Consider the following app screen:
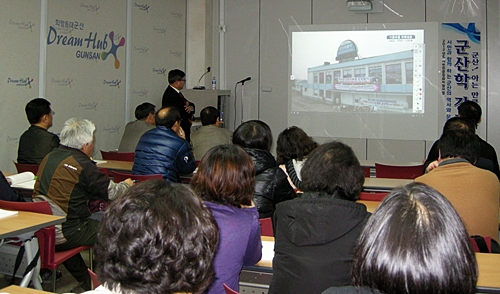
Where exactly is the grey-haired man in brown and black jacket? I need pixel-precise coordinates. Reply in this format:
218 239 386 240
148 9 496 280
33 118 133 290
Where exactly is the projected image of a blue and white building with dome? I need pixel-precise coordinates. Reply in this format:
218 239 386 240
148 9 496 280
290 29 425 114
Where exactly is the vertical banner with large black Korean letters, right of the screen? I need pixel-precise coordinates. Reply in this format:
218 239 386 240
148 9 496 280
441 23 481 120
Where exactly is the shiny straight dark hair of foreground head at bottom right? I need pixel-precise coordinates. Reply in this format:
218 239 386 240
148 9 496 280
352 183 478 293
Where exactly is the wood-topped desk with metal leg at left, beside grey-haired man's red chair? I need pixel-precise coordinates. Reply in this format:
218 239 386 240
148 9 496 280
0 211 66 290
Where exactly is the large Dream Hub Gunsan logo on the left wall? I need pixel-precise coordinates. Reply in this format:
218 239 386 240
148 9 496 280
47 26 125 69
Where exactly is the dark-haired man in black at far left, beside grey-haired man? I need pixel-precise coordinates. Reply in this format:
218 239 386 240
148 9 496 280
17 98 59 164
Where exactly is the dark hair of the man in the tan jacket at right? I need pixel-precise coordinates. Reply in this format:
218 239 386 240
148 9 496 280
438 131 481 164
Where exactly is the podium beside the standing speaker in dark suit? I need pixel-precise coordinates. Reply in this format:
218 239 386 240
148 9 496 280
181 89 231 122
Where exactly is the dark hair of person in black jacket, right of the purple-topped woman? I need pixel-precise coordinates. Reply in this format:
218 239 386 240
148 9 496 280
300 141 365 201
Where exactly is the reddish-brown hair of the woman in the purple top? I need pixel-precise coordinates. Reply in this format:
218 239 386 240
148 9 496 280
191 145 255 207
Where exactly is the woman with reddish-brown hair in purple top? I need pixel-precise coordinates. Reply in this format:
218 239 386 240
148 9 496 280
191 145 262 294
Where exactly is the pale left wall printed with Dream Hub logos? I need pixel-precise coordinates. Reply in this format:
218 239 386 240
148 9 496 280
0 0 187 173
